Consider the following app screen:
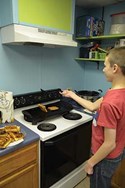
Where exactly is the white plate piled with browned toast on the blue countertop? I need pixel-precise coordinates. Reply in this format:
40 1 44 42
0 125 26 149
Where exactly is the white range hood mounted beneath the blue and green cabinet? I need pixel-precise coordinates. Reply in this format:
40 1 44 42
1 24 77 47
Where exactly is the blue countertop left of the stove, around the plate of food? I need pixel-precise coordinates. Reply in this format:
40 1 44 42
0 120 40 156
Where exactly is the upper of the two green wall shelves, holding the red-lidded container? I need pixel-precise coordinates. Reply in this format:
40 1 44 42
76 34 125 40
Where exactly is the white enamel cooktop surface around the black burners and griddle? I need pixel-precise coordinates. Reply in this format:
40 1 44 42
14 106 92 141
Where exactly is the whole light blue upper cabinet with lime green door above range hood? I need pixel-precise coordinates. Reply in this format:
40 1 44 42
0 0 75 33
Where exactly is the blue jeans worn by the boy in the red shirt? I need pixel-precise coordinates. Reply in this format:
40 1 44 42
90 153 125 188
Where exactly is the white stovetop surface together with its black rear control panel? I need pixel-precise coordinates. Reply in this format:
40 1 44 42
14 89 92 141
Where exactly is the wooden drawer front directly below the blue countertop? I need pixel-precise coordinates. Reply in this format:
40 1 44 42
0 142 38 178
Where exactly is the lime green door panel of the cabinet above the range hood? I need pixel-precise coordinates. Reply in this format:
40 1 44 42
18 0 74 33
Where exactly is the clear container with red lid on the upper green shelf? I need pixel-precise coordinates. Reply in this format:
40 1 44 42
110 12 125 34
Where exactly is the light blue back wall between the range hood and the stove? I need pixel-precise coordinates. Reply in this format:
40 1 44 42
0 42 84 94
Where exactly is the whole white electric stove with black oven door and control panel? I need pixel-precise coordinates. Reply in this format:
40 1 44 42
14 89 92 188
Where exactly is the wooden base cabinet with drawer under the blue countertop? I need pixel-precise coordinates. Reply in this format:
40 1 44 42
0 141 39 188
